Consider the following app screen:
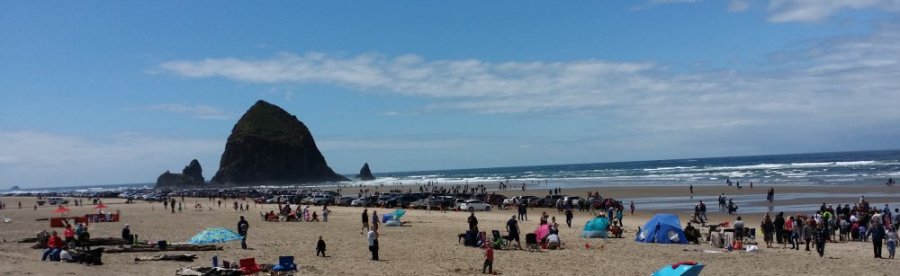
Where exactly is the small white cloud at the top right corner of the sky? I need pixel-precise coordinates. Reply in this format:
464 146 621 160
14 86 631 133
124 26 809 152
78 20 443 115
768 0 900 22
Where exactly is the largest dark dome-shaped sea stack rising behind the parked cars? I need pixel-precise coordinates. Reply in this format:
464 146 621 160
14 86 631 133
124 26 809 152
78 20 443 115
212 101 348 186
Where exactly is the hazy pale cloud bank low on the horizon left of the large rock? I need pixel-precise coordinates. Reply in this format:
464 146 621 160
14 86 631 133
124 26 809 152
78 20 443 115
0 131 225 188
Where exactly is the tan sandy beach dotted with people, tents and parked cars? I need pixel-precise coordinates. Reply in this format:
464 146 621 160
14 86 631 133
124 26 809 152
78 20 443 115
0 186 900 275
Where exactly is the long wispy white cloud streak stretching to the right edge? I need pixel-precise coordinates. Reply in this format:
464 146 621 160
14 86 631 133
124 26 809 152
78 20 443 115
160 25 900 138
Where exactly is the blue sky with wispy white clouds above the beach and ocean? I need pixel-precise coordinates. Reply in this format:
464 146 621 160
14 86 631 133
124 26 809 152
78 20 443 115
0 0 900 188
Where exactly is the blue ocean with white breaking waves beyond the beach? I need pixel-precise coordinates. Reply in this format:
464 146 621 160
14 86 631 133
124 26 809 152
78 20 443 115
8 150 900 192
